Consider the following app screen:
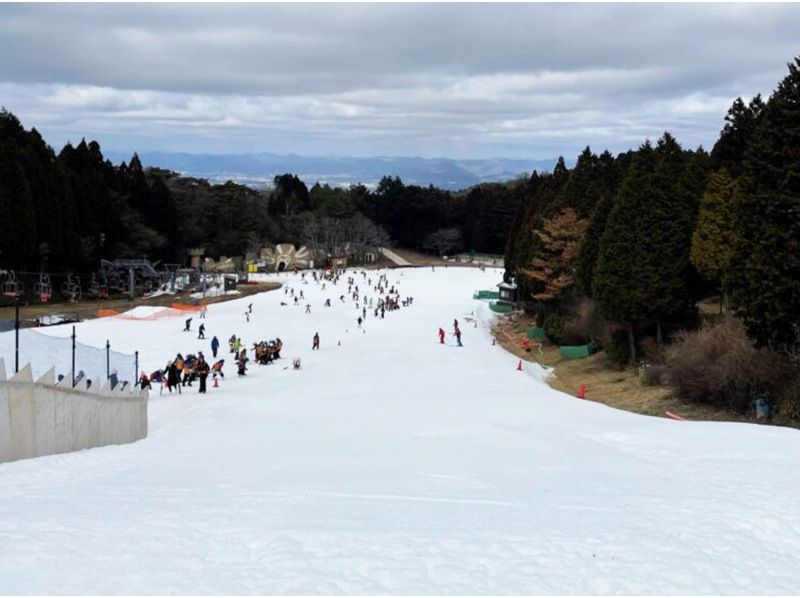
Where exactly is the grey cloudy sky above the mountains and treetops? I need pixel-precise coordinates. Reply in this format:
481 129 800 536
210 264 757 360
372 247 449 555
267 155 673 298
0 4 800 159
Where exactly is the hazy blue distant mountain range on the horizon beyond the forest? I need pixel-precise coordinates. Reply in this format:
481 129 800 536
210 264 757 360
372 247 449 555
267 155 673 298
106 152 556 189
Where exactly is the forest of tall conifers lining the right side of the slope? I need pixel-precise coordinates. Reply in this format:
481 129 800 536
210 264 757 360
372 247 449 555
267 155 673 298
505 58 800 416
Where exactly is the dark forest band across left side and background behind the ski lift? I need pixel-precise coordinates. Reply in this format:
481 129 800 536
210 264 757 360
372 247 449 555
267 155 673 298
0 110 525 271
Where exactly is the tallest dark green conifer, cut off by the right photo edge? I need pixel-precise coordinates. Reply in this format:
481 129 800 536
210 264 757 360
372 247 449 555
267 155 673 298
730 57 800 351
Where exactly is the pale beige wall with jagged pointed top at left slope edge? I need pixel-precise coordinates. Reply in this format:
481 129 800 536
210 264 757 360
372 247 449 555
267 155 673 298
0 359 148 463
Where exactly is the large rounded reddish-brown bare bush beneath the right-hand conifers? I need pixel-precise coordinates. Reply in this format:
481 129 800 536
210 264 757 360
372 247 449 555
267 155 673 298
667 317 789 413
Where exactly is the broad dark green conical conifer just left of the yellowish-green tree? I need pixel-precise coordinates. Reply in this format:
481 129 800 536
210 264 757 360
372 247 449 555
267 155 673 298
592 133 697 363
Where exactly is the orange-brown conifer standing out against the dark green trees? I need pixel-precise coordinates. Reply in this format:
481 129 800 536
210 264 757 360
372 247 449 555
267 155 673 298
520 208 588 302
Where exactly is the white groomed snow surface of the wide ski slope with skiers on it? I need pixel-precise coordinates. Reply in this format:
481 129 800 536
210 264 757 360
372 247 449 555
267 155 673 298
0 268 800 594
